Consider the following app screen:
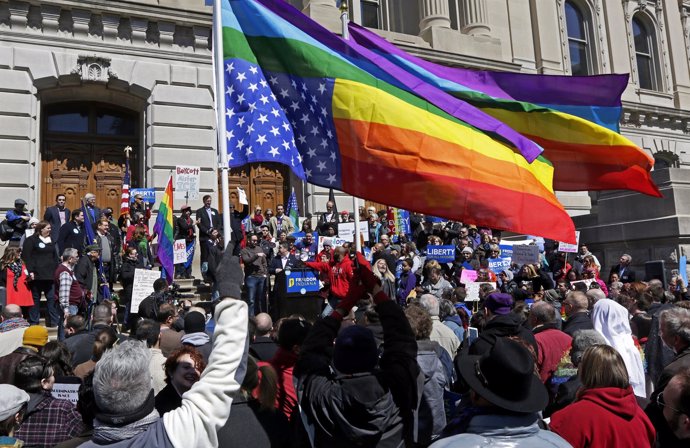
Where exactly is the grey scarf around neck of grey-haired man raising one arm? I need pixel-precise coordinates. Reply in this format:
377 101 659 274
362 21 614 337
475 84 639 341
93 389 160 445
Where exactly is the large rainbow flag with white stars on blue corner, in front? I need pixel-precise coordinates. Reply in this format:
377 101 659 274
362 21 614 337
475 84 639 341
222 0 574 242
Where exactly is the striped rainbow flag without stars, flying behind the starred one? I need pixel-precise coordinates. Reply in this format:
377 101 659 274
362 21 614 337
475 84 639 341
349 23 660 196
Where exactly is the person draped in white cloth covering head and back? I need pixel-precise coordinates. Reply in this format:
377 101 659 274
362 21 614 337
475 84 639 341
592 299 647 397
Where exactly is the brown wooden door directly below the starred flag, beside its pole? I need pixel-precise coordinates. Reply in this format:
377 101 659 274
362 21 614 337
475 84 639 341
218 163 289 213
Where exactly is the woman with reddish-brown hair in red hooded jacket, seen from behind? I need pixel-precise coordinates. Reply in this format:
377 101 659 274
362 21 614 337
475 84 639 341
550 345 656 448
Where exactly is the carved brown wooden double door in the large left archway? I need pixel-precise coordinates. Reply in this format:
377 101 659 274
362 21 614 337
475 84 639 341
42 141 137 216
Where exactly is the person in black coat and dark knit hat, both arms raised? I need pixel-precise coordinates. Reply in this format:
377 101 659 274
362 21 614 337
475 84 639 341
294 254 419 447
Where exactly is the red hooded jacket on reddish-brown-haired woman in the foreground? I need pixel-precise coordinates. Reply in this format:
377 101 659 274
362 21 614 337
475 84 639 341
550 387 656 448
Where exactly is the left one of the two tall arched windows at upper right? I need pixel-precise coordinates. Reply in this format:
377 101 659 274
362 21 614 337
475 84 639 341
565 1 596 75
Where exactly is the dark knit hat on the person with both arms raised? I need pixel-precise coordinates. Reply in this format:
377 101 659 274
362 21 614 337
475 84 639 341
333 325 379 374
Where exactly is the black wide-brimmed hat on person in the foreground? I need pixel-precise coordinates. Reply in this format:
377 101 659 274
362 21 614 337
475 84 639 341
459 338 549 413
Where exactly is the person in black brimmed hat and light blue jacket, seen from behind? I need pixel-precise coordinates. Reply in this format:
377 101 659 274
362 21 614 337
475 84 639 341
431 337 570 448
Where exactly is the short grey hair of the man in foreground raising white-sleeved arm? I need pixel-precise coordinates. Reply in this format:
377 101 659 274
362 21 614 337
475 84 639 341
93 340 152 414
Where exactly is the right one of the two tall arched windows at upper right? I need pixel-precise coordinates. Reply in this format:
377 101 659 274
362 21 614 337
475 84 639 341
632 14 661 90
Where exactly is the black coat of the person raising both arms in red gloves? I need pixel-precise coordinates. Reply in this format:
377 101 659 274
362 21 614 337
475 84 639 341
294 300 421 447
